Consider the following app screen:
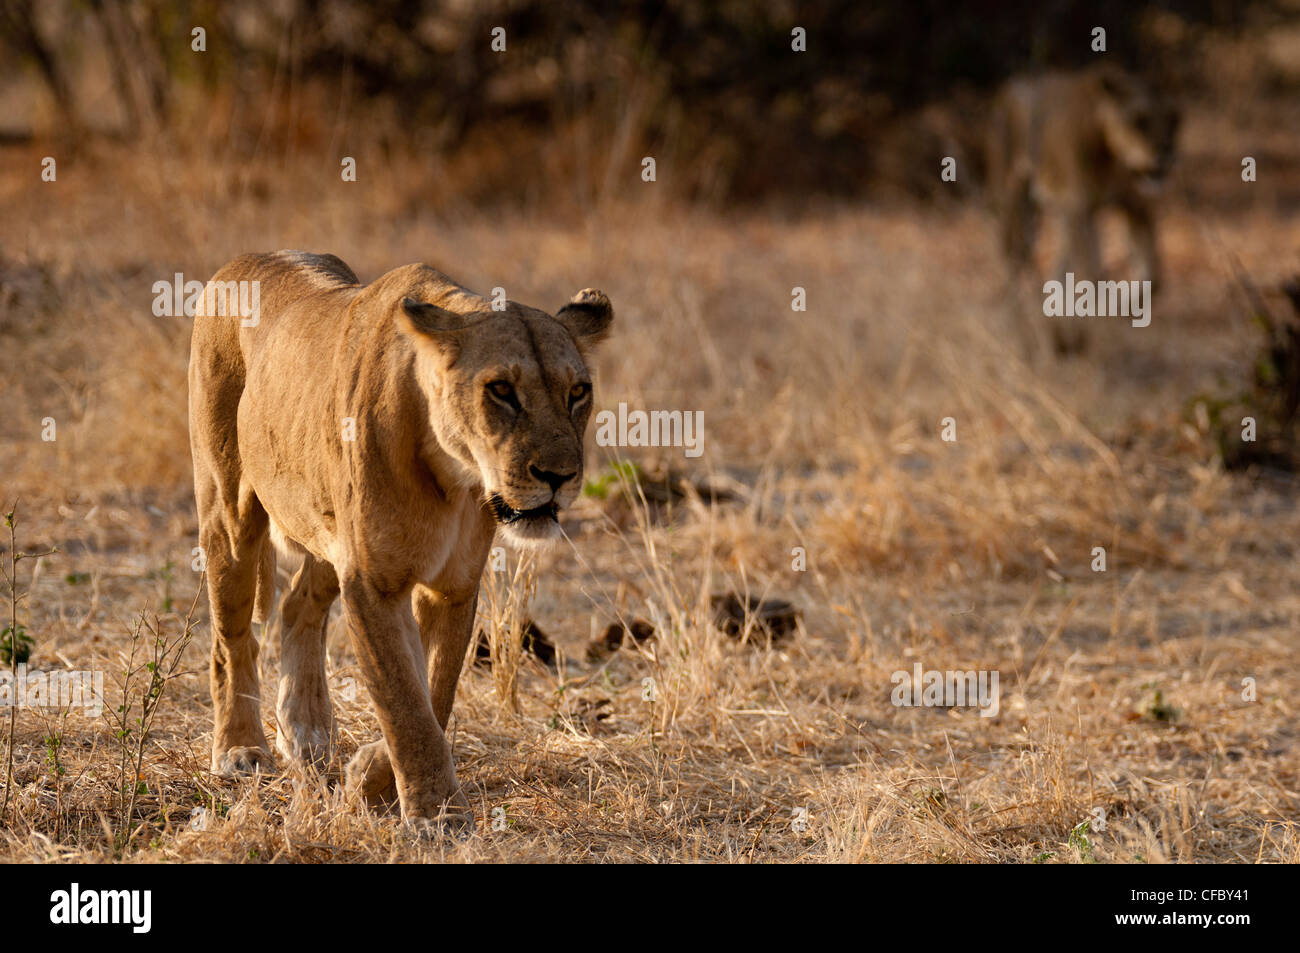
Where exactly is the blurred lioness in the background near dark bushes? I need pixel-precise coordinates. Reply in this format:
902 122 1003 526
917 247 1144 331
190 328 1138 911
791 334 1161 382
987 64 1179 351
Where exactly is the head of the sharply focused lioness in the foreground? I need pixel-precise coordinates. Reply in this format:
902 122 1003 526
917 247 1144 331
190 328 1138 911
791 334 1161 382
400 285 614 545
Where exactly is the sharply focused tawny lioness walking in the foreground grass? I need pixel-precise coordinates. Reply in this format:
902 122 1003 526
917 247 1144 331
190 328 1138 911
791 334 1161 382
190 251 614 822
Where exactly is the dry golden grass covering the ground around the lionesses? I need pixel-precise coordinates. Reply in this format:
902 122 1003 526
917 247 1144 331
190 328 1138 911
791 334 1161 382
0 91 1300 862
